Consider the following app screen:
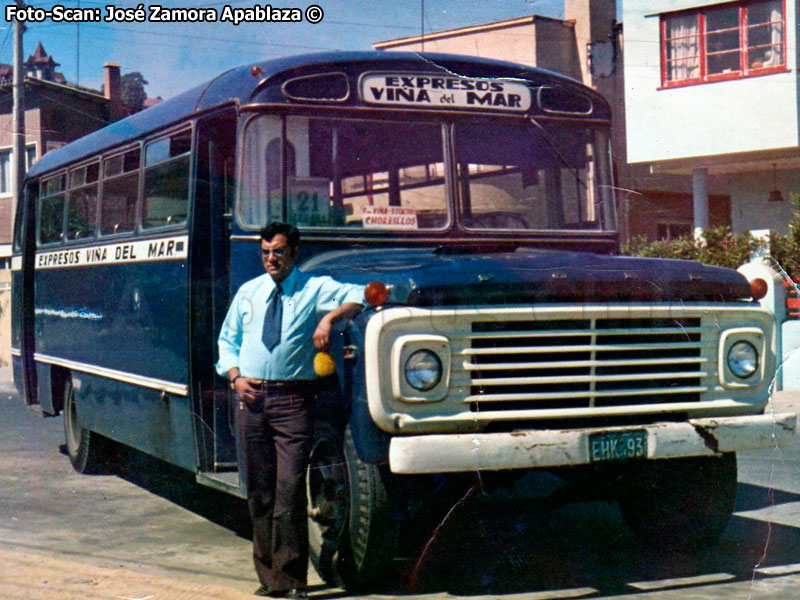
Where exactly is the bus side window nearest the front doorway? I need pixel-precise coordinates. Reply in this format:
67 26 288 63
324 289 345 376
142 129 192 229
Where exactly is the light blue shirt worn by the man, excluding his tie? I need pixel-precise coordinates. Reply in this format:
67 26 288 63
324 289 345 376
217 269 365 380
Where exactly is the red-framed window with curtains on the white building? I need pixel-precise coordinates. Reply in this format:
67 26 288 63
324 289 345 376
661 0 786 87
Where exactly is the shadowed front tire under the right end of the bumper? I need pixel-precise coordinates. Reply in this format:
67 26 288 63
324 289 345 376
618 453 736 552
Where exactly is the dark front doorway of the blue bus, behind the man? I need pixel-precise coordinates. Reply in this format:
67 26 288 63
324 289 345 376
189 110 240 492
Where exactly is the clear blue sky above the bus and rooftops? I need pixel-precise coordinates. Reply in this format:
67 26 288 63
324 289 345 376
0 0 564 99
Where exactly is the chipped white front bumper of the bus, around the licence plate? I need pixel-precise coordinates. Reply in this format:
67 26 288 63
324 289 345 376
389 413 797 474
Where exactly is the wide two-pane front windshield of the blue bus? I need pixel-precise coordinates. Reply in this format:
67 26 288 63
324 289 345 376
237 115 614 232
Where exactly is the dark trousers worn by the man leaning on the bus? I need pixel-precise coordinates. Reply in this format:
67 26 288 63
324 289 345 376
237 392 312 590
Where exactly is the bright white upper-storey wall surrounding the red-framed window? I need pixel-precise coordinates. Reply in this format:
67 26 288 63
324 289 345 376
622 0 798 162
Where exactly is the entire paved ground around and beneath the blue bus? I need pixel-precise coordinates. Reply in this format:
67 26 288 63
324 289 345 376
0 384 800 600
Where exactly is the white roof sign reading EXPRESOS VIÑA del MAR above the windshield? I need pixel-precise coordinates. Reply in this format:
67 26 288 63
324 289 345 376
361 73 531 112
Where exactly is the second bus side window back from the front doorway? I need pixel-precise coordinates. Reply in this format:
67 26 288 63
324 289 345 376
100 148 140 235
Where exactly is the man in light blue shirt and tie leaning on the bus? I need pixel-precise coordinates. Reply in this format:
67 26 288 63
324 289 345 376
217 223 364 598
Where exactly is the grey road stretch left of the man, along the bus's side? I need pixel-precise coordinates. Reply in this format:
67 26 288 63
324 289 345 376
0 386 268 600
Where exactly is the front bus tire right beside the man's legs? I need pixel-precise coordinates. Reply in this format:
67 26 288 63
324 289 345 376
308 421 398 590
